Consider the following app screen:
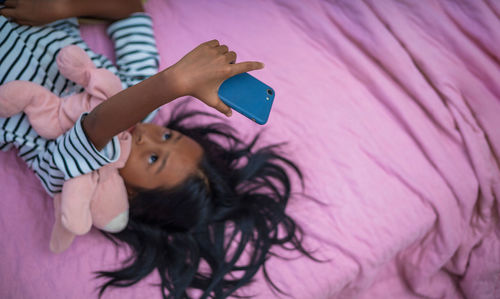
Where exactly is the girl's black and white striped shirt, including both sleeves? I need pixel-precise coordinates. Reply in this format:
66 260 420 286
0 13 159 195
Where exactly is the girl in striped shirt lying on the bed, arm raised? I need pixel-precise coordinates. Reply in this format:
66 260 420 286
0 0 313 298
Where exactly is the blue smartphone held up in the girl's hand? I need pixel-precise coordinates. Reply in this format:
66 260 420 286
218 73 275 125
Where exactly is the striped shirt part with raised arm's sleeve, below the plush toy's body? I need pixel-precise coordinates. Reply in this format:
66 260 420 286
0 113 120 196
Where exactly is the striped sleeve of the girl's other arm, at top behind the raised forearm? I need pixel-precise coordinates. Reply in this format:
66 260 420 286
107 13 159 86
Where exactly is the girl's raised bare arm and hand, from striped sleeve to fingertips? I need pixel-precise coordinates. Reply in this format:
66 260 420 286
82 40 264 150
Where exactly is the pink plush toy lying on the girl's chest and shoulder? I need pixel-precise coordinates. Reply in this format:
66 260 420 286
0 46 131 253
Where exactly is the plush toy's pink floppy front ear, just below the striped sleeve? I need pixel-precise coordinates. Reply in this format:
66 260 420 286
61 171 99 235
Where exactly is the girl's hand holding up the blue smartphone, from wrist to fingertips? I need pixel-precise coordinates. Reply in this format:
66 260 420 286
168 40 264 117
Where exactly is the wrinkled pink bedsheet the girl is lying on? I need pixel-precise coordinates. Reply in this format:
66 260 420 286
0 0 500 299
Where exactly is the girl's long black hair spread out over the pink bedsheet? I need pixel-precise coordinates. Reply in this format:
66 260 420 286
98 104 316 298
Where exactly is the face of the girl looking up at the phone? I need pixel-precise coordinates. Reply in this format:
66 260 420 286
120 123 203 191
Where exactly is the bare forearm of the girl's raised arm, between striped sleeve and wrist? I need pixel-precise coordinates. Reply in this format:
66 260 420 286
82 69 180 150
